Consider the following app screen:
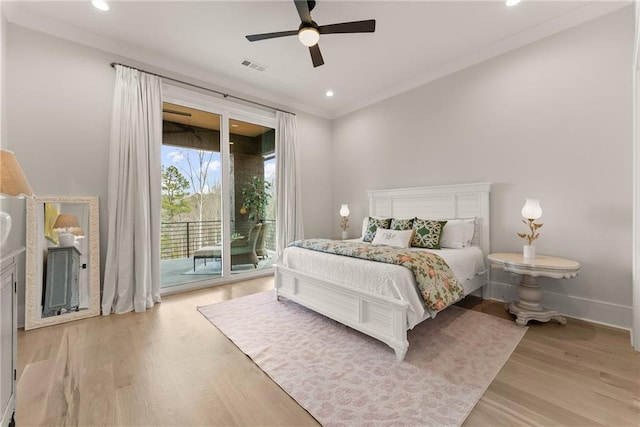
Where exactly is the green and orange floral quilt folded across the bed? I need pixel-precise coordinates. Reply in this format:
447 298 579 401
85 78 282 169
289 239 464 316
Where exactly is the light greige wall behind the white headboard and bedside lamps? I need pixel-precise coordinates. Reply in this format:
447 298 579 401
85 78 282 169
333 7 634 328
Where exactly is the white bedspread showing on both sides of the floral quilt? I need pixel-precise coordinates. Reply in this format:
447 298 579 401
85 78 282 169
280 246 485 328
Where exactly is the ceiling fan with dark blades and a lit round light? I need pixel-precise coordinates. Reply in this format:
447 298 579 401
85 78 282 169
246 0 376 67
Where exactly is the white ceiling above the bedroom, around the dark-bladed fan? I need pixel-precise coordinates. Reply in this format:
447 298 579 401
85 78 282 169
2 0 631 118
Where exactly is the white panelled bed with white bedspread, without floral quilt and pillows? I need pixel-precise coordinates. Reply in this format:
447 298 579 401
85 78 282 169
275 183 491 361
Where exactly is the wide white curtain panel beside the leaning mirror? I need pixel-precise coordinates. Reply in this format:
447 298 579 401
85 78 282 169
102 65 162 315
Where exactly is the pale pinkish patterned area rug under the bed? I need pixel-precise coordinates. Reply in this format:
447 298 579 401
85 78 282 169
198 291 526 426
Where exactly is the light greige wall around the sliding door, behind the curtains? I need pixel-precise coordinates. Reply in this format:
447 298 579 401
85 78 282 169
3 24 332 320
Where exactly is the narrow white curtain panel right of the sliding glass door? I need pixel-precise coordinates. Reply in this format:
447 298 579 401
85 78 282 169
276 111 304 258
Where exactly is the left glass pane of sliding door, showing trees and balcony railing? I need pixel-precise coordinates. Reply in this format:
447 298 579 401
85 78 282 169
160 103 222 287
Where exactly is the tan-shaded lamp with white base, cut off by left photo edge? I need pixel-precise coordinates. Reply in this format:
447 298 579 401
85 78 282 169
0 150 33 246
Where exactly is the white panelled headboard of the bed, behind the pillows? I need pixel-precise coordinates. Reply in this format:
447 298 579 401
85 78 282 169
367 182 491 255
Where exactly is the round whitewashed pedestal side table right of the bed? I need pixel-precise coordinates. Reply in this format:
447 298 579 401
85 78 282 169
488 253 580 326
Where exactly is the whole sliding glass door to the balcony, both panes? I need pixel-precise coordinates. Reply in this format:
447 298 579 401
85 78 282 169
161 97 277 289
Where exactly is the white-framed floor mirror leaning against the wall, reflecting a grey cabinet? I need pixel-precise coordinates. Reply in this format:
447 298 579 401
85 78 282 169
25 196 100 330
